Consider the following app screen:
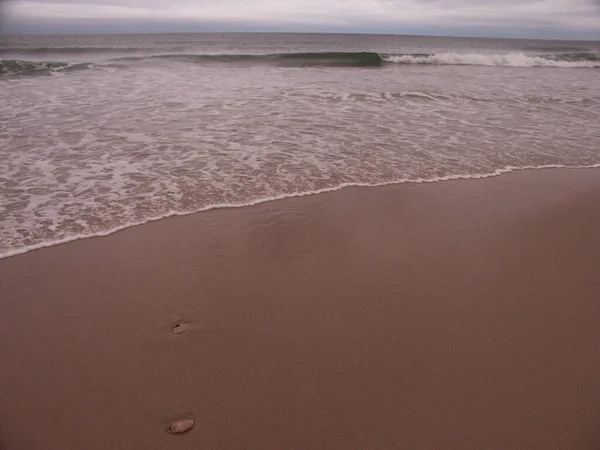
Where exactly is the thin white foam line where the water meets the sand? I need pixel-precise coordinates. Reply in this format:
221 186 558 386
0 163 600 261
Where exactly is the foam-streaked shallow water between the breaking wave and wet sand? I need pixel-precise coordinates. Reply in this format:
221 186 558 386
0 61 600 257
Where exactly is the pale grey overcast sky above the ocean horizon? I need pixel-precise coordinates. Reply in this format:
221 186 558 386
0 0 600 39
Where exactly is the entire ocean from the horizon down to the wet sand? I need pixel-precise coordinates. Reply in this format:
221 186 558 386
0 34 600 257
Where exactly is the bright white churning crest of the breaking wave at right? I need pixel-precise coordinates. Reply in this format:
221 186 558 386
384 52 600 68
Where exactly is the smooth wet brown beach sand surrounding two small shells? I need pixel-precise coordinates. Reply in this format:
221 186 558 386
0 170 600 450
